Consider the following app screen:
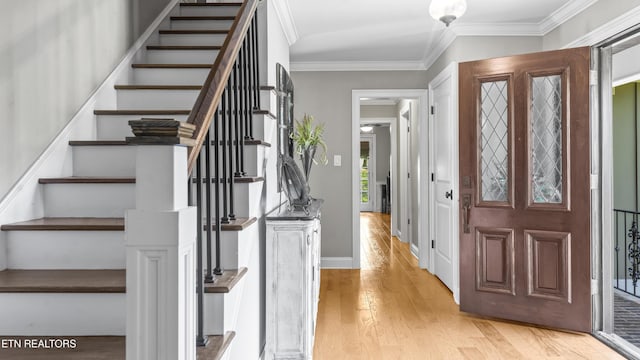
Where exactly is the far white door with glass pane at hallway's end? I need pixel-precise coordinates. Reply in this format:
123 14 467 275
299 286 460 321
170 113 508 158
359 134 376 211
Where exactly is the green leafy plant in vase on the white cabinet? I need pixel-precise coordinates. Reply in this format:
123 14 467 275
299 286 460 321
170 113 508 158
291 114 328 183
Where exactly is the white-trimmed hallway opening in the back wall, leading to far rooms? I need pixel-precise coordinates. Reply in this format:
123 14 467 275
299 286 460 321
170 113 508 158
352 90 427 268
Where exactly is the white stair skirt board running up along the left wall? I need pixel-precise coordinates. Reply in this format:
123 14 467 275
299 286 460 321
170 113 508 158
0 0 179 270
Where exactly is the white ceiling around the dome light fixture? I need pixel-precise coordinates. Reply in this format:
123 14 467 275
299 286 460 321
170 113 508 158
274 0 597 70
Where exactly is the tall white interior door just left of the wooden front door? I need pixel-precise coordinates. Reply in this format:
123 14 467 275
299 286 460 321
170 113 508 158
429 63 458 291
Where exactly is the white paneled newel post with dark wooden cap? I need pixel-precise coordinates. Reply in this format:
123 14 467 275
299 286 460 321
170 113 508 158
125 119 196 360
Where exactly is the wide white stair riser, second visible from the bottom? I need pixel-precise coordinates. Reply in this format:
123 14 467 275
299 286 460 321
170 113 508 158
7 231 125 270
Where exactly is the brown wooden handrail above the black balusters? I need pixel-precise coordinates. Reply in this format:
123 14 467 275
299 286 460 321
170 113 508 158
187 0 258 174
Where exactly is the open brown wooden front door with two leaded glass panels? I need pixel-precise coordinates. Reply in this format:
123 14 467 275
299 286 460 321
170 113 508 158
459 48 591 332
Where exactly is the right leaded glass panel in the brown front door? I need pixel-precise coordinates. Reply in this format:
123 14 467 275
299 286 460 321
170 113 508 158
530 75 563 204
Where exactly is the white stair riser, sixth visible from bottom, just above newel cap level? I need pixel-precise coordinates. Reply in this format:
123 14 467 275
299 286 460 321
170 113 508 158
118 90 200 110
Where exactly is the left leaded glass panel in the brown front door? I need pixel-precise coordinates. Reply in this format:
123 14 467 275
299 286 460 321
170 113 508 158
480 80 509 202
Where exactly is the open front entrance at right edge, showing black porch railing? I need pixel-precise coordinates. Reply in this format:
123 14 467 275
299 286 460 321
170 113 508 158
605 36 640 351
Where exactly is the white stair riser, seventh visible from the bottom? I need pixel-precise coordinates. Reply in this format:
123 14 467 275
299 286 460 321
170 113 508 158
133 68 211 85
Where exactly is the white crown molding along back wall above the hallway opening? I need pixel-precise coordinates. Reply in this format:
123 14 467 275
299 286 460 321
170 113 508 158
289 60 426 71
